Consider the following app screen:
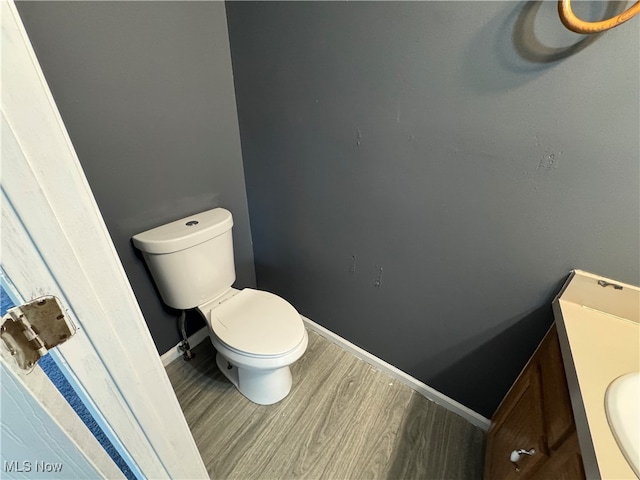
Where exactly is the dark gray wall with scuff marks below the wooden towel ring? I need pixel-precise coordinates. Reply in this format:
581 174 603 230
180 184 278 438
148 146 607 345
227 1 640 416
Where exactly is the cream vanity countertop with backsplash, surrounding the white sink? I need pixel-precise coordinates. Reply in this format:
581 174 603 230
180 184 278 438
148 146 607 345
553 270 640 480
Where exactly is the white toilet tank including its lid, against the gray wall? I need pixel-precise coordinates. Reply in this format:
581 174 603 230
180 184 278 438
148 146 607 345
133 208 236 310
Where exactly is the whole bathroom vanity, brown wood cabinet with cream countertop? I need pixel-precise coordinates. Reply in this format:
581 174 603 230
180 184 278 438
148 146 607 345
484 271 640 480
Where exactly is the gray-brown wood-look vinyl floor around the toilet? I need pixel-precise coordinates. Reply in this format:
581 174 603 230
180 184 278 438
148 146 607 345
167 331 485 480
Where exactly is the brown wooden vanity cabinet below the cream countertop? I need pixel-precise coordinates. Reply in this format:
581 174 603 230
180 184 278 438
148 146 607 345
484 325 585 480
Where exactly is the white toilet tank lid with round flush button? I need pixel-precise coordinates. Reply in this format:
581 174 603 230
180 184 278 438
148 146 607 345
133 208 233 254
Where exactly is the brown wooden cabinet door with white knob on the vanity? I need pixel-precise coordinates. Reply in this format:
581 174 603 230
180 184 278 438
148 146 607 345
485 362 548 480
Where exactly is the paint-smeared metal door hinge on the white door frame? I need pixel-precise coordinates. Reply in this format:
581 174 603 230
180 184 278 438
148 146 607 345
0 296 76 370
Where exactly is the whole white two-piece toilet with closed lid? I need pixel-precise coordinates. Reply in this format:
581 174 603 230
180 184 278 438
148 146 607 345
133 208 308 405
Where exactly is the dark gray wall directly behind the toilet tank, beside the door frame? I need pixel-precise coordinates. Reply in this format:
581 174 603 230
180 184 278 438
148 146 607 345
18 1 255 353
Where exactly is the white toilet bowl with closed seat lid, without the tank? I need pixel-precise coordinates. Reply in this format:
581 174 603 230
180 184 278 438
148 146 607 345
198 288 308 405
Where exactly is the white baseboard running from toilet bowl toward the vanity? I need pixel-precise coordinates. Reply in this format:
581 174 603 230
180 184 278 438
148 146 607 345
302 316 491 431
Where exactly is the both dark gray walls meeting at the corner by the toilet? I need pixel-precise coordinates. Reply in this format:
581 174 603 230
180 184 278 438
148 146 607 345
18 1 640 416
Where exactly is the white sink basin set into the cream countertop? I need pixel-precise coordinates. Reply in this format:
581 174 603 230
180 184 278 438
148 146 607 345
605 372 640 478
